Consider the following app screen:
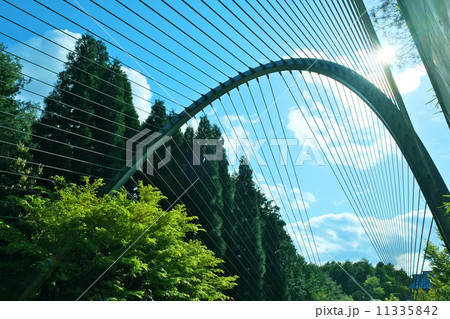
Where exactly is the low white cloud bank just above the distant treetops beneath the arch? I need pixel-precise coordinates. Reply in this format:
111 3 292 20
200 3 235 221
286 210 431 270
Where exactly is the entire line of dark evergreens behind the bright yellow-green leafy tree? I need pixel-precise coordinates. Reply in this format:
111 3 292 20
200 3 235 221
0 35 414 300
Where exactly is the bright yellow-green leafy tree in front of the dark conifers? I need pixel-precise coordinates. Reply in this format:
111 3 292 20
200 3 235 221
0 179 236 300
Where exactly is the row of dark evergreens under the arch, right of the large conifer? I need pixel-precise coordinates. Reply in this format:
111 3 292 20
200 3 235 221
139 100 344 300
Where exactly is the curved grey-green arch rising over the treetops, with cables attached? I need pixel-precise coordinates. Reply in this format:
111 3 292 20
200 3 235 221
104 58 450 251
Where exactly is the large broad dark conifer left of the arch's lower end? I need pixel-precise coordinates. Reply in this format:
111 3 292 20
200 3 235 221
34 34 139 181
